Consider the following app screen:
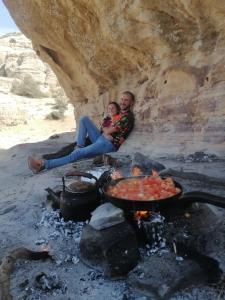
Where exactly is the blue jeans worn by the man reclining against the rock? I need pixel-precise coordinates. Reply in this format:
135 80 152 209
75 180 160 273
45 117 117 169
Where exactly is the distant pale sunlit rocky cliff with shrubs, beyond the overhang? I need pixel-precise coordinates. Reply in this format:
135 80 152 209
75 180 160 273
0 33 65 98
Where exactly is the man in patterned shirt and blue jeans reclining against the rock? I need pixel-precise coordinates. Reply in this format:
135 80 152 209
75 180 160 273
28 91 135 173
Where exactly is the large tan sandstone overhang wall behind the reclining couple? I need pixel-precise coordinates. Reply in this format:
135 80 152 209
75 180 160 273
3 0 225 156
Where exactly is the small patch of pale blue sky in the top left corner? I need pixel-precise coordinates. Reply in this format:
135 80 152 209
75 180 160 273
0 0 20 35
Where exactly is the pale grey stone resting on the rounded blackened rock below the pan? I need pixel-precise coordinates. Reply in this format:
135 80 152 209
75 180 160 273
89 203 125 230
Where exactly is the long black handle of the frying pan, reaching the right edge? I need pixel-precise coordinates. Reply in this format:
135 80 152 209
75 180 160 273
178 191 225 208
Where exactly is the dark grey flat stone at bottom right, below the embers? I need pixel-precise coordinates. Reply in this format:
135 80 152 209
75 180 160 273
128 252 204 299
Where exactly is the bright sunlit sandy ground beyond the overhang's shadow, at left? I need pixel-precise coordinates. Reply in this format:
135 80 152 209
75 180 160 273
0 92 76 149
